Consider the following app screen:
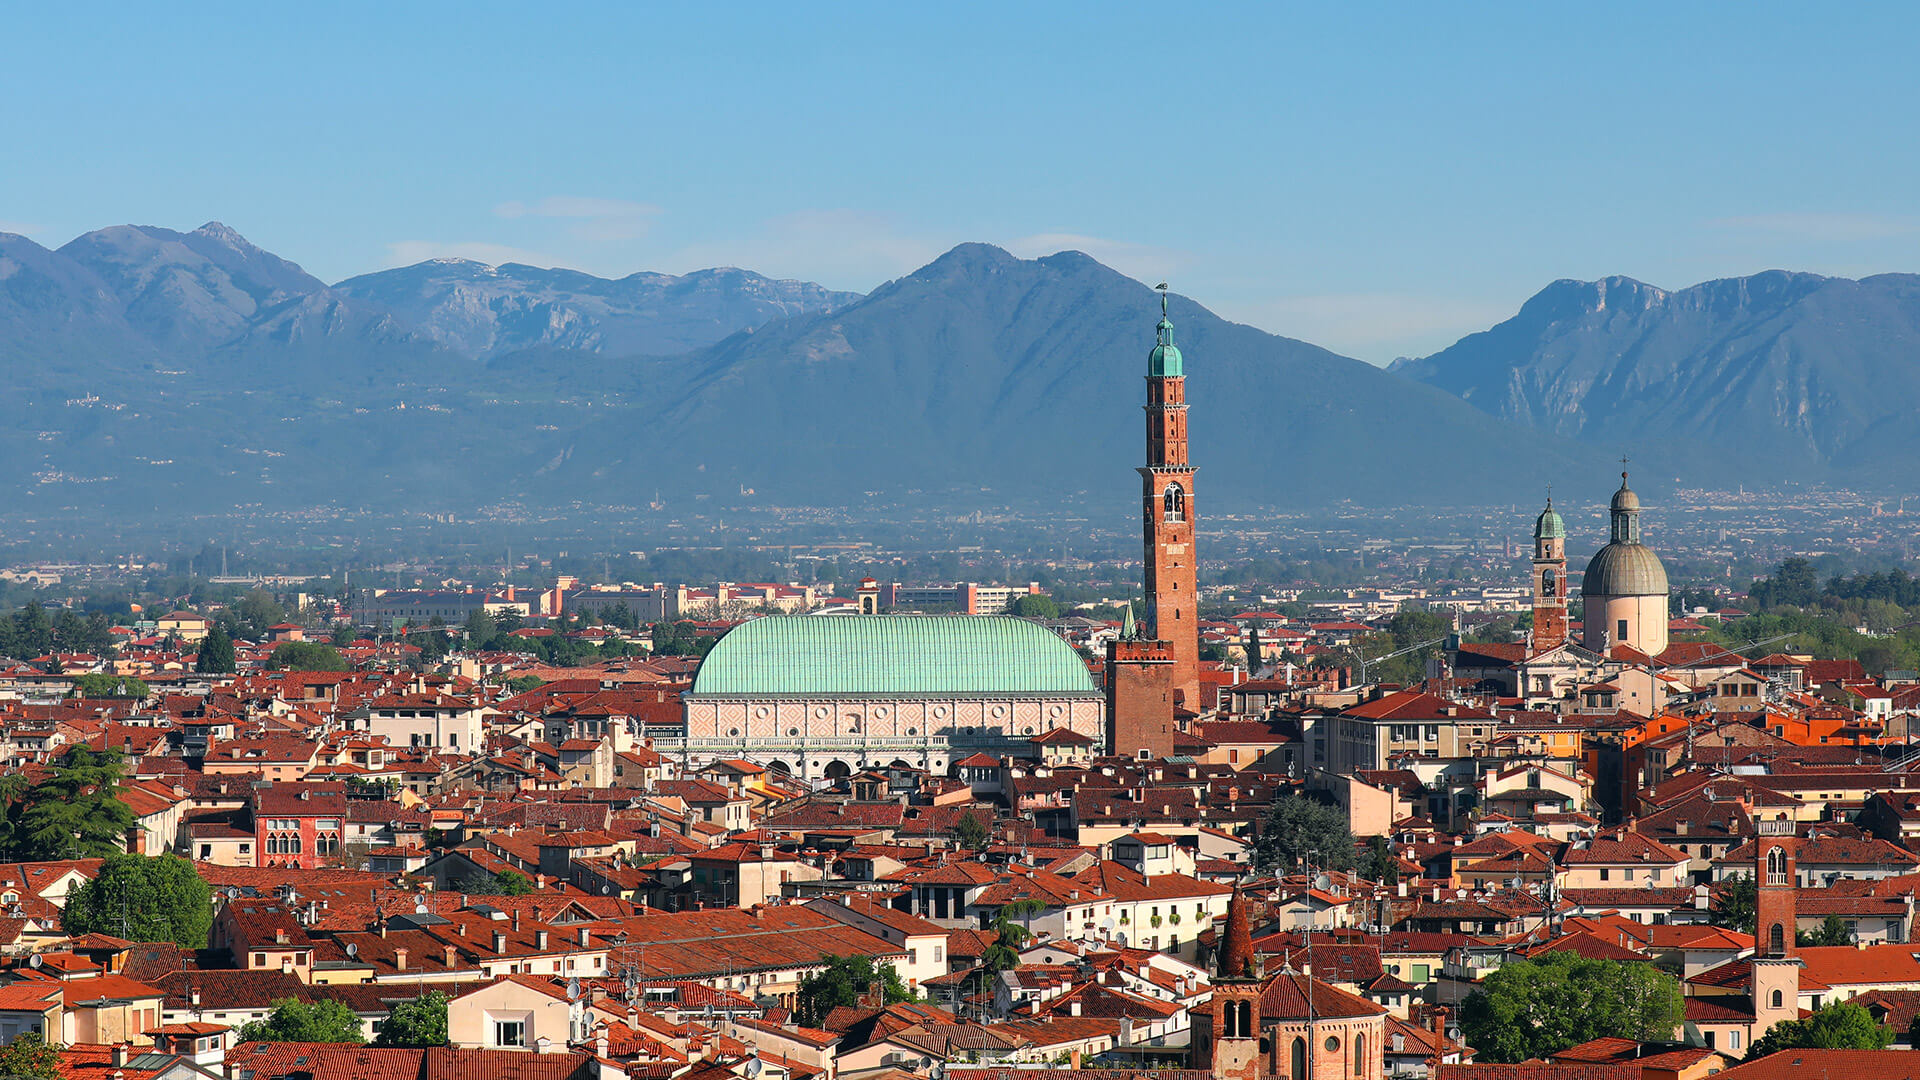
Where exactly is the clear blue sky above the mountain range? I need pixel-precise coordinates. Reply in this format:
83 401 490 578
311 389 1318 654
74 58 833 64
0 2 1920 363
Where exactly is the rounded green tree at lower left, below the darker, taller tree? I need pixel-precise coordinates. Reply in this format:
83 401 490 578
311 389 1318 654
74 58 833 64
60 855 213 949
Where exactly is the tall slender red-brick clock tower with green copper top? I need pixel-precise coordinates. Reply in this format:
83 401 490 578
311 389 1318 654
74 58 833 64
1140 284 1200 709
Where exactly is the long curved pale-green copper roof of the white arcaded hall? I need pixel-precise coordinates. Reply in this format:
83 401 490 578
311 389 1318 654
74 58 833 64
693 615 1098 698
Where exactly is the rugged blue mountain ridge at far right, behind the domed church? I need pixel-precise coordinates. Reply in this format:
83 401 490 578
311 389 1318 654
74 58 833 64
1392 271 1920 484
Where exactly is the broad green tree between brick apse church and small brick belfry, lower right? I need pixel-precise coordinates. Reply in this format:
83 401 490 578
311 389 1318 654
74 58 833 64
1459 953 1686 1063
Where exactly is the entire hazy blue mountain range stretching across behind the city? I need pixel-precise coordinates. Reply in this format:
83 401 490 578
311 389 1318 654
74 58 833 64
0 223 1896 513
